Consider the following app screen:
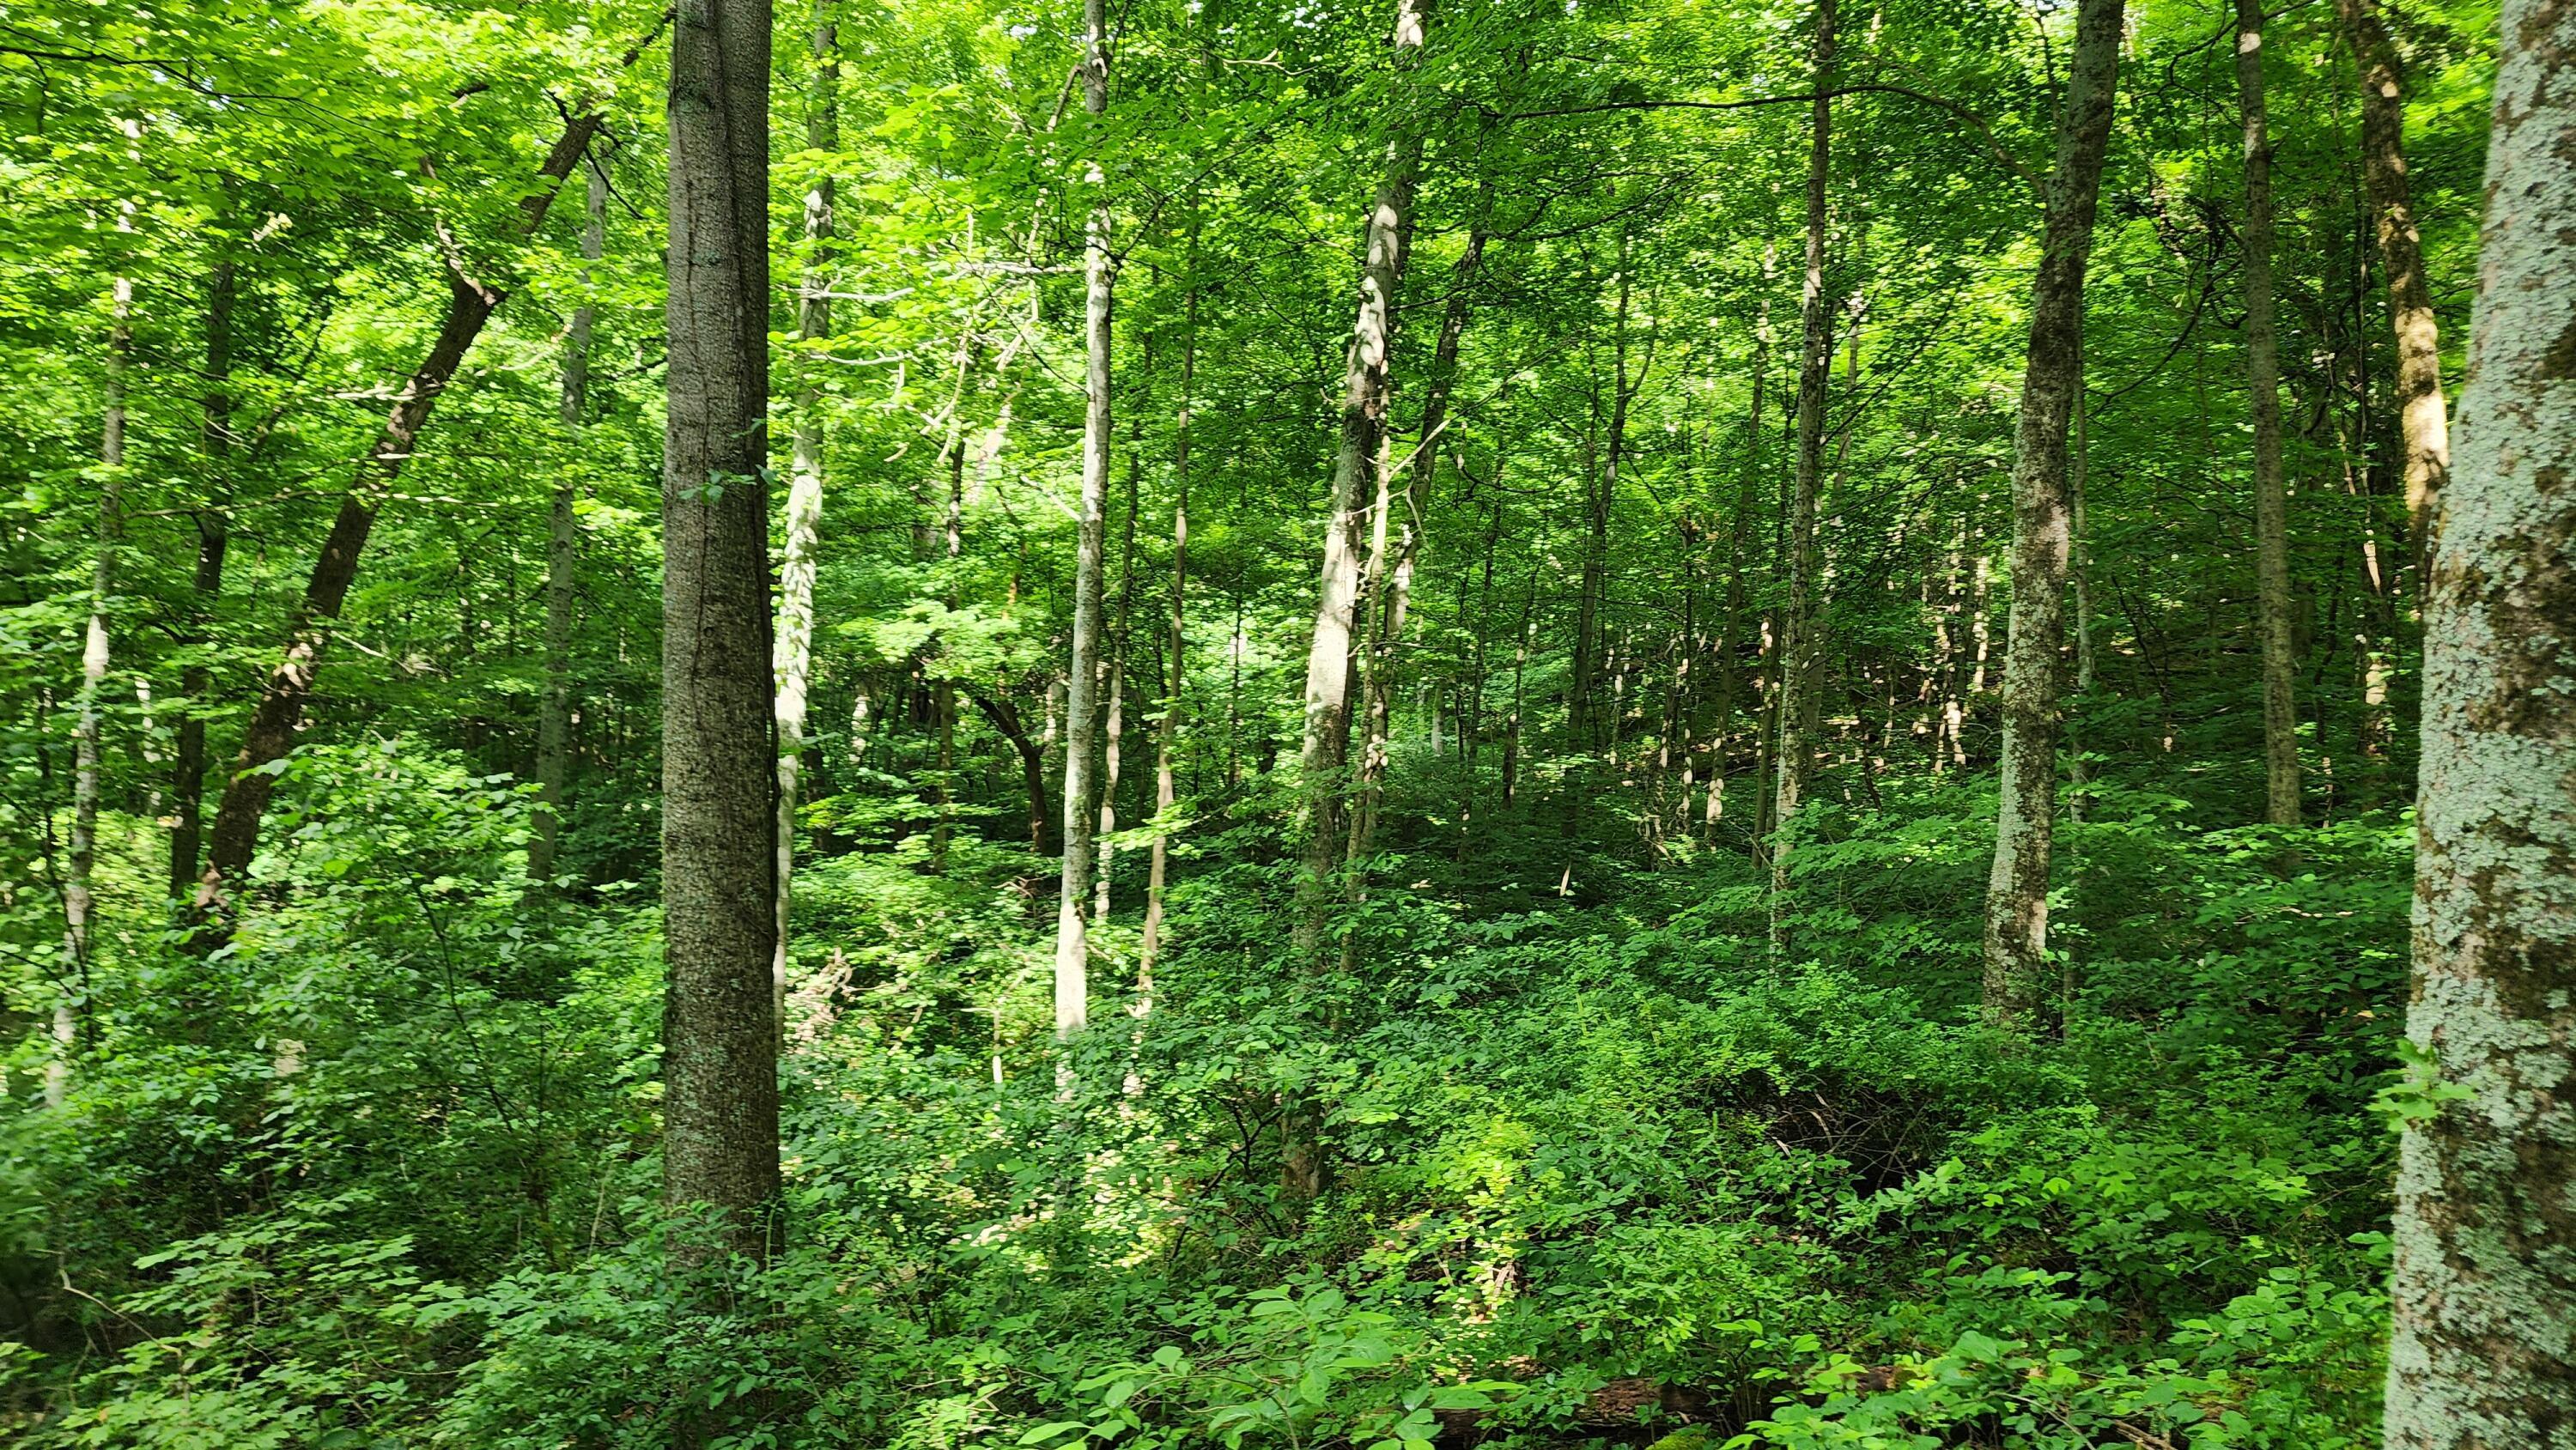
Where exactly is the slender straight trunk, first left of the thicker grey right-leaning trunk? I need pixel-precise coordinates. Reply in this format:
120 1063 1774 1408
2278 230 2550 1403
1770 0 1834 950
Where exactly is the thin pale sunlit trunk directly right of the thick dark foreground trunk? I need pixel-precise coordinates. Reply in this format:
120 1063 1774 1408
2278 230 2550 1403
770 0 840 1030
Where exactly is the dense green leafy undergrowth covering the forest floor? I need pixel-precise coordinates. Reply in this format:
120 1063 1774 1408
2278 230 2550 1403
0 755 2406 1450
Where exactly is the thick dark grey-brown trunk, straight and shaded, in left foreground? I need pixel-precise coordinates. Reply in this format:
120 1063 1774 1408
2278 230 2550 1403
662 0 778 1257
